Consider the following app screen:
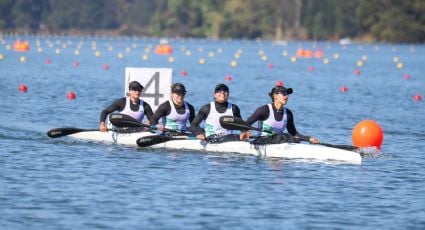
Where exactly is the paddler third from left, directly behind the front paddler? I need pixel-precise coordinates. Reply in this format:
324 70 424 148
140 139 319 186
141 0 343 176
190 84 241 141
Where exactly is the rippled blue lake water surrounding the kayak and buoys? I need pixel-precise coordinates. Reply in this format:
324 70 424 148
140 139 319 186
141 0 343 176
0 36 425 229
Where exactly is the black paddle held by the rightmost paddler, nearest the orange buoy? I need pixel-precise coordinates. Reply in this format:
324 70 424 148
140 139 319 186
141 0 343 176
220 116 357 150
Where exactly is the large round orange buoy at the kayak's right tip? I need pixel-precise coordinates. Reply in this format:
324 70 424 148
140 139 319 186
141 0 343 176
352 120 384 149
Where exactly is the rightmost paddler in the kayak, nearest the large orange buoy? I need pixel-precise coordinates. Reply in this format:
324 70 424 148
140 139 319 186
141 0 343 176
240 86 320 144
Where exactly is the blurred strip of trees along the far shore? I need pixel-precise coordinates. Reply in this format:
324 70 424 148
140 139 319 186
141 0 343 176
0 0 425 43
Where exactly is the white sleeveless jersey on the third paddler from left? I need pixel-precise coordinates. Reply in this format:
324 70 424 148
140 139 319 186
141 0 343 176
205 102 233 137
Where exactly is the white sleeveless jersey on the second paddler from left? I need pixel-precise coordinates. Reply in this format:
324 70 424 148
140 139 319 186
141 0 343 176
162 100 190 131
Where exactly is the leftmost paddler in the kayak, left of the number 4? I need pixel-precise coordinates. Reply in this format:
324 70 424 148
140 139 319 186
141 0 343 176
99 81 153 132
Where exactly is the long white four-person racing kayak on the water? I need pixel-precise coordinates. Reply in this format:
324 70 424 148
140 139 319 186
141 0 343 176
68 131 362 164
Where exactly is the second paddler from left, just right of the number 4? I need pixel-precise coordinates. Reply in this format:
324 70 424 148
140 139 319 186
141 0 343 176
151 83 195 132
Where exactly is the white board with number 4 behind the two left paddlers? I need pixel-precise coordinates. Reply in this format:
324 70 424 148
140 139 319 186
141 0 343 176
124 67 173 111
